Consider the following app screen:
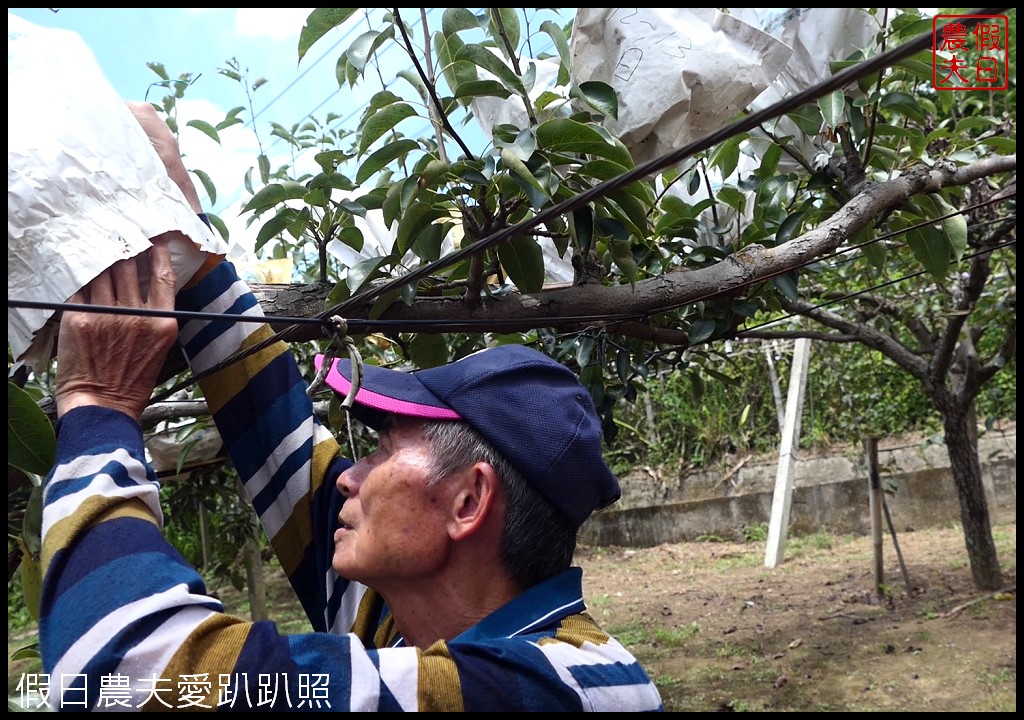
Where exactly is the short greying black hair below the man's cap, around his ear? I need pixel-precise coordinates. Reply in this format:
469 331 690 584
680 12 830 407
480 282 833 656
423 420 577 590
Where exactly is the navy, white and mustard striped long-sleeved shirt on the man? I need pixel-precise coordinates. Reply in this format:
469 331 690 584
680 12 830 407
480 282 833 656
39 262 664 712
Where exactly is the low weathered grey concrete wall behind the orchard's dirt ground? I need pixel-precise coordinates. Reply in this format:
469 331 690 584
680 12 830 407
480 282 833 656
581 425 1017 547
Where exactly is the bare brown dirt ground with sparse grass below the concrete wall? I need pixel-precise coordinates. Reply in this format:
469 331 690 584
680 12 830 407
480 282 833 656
578 523 1017 712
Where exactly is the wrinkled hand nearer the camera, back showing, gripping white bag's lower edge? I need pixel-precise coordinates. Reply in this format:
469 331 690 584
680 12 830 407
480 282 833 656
56 236 178 420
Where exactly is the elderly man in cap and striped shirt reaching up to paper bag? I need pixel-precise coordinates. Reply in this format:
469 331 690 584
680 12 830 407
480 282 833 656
40 104 663 712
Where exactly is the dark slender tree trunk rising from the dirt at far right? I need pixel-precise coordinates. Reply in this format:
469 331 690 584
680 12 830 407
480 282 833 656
937 400 1002 590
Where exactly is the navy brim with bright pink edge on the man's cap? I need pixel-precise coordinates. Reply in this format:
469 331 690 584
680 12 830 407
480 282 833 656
313 354 462 428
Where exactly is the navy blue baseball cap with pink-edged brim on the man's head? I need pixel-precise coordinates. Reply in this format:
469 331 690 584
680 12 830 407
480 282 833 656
315 345 622 527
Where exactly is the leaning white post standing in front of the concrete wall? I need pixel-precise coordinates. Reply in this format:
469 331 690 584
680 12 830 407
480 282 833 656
765 338 811 567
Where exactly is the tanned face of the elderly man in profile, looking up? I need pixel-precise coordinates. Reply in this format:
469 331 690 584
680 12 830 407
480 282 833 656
332 417 451 593
